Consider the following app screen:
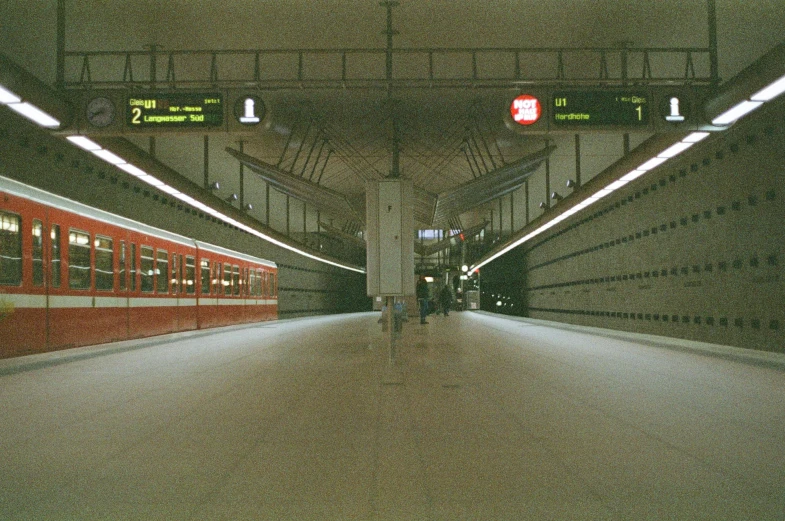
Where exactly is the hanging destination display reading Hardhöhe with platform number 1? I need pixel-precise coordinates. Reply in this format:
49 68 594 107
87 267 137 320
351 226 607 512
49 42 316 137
551 90 651 127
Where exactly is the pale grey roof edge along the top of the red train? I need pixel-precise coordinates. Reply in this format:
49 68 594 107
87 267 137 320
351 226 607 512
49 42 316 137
0 176 276 268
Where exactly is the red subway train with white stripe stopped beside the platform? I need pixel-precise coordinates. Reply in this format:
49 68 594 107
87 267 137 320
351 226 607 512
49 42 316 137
0 176 278 358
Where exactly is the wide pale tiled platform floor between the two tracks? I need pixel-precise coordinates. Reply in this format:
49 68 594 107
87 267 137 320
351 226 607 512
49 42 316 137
0 312 785 521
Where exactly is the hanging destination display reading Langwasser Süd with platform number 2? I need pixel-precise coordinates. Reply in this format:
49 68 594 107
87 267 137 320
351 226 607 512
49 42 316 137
126 92 224 129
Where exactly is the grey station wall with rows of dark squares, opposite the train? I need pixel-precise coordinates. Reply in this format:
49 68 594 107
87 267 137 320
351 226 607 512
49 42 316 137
520 103 785 352
